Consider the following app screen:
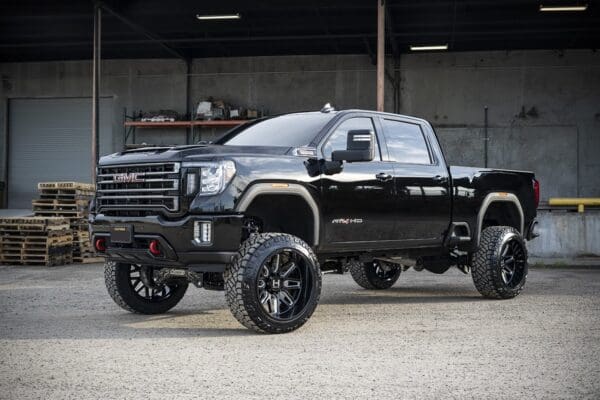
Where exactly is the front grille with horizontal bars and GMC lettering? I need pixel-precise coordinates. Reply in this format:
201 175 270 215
96 163 181 216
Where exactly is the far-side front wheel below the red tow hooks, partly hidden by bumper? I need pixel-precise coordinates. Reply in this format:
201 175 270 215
104 261 188 314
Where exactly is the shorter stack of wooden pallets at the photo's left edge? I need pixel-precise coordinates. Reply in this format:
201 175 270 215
0 217 73 266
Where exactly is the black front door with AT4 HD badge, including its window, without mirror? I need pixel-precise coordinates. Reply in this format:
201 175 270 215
321 115 396 251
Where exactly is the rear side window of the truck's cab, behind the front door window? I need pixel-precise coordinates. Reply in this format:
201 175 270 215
383 119 431 164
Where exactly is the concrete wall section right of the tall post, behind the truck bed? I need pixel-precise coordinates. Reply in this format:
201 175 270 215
402 51 600 199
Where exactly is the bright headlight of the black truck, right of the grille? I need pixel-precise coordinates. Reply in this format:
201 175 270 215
183 160 235 196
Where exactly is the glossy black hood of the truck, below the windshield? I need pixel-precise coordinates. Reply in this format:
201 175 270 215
98 144 291 166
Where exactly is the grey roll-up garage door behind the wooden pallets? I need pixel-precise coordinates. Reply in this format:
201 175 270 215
7 98 114 209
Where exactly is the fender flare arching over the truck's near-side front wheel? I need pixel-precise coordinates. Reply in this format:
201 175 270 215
235 182 321 246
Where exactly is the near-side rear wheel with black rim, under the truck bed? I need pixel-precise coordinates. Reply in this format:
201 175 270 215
471 226 528 299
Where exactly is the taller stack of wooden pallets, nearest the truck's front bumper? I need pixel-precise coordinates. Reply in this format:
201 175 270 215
32 182 102 263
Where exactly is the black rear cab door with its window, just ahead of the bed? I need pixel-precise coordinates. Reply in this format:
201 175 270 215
378 116 450 246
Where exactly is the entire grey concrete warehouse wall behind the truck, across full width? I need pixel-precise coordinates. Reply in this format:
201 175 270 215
0 50 600 199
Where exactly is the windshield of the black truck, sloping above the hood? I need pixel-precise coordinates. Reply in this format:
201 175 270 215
216 113 333 147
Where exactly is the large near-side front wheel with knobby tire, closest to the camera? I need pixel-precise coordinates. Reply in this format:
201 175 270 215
224 233 321 333
